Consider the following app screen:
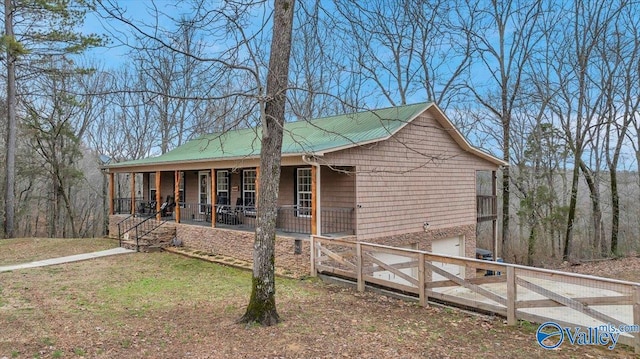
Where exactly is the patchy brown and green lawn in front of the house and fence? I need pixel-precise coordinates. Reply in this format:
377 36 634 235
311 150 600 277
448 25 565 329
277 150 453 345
0 239 634 358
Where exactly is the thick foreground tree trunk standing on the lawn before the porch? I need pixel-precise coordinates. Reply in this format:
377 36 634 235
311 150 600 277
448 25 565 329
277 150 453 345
240 0 295 326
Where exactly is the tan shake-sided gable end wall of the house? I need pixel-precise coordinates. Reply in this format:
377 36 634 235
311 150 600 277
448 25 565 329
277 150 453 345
323 111 495 240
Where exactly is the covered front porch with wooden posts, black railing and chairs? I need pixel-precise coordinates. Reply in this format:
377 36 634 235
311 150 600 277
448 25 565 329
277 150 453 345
110 166 356 237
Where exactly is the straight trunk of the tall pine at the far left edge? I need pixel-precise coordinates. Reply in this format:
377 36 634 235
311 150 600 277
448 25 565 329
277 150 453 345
4 0 17 238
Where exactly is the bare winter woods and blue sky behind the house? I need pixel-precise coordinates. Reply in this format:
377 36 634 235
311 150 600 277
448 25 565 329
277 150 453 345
0 0 640 265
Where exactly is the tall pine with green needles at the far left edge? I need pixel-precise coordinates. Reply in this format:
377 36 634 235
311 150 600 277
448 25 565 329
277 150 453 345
3 0 103 237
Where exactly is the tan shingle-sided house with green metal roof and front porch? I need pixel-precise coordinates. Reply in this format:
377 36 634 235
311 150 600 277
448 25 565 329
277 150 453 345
107 103 507 272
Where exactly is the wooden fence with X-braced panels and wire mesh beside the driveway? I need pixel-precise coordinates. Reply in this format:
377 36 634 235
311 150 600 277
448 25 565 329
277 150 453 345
311 236 640 353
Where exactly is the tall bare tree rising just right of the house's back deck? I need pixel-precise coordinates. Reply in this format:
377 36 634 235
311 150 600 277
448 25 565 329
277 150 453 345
464 0 544 255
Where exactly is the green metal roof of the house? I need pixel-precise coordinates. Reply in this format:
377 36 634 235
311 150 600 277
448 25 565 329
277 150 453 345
108 102 431 167
